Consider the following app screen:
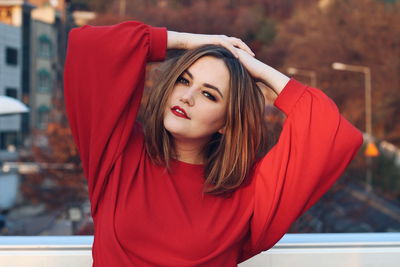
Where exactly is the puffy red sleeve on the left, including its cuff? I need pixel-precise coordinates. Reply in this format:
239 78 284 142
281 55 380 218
64 21 167 216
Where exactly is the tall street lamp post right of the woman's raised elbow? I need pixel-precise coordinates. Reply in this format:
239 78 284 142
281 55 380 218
332 62 378 191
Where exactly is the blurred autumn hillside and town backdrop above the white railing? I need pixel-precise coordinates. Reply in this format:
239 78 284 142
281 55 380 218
0 0 400 238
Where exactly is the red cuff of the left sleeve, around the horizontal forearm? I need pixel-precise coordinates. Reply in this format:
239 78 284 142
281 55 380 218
149 27 167 61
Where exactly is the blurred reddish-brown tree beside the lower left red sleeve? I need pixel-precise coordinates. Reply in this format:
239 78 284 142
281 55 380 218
21 99 88 210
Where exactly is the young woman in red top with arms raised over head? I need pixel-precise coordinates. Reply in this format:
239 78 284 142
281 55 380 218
65 21 362 266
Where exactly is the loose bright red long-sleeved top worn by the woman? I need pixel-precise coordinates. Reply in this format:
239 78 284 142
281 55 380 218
65 21 363 267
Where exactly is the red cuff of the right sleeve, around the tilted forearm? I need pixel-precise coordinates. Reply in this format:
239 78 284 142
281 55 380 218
274 78 307 115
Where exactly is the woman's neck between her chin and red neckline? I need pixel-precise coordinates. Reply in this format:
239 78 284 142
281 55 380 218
174 139 206 164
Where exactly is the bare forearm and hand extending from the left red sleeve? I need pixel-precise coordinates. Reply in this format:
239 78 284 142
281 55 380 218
167 31 255 58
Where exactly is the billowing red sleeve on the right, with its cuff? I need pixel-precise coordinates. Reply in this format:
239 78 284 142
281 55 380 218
240 79 363 261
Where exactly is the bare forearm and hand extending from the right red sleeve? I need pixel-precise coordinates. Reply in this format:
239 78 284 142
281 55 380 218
235 48 290 95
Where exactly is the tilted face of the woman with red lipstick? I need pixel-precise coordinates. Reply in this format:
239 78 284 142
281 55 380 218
164 56 230 141
